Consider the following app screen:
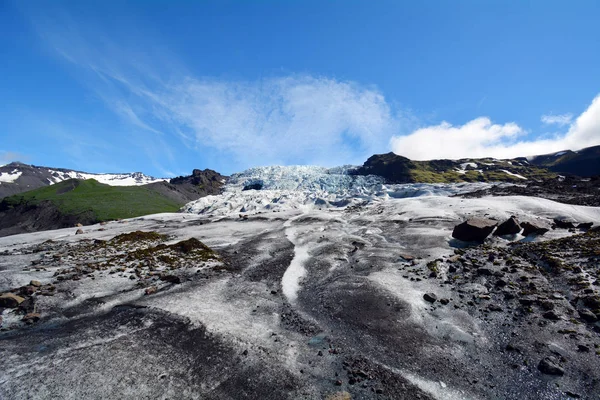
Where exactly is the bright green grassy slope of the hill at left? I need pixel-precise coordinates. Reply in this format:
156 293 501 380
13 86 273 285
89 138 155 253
0 179 182 222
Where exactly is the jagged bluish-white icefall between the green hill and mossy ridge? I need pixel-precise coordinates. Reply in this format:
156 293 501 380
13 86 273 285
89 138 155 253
182 165 489 216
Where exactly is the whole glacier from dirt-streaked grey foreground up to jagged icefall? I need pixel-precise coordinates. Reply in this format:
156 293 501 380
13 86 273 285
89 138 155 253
0 180 600 399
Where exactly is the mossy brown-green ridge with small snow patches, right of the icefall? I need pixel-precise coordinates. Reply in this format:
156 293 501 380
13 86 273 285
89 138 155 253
352 153 556 183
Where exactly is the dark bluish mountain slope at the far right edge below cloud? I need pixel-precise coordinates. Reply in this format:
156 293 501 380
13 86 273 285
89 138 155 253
529 146 600 177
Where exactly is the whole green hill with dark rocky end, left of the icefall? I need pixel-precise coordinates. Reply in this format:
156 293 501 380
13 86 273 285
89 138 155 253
0 170 227 236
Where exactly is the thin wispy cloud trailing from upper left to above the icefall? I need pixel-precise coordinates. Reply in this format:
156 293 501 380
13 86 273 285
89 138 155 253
25 9 402 168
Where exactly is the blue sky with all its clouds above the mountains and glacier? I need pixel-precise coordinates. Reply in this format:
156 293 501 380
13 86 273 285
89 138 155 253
0 0 600 176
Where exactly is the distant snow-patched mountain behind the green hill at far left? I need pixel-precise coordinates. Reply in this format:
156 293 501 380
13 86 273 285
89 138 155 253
0 162 168 198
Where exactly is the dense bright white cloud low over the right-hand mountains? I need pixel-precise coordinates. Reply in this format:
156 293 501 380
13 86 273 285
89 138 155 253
390 96 600 160
